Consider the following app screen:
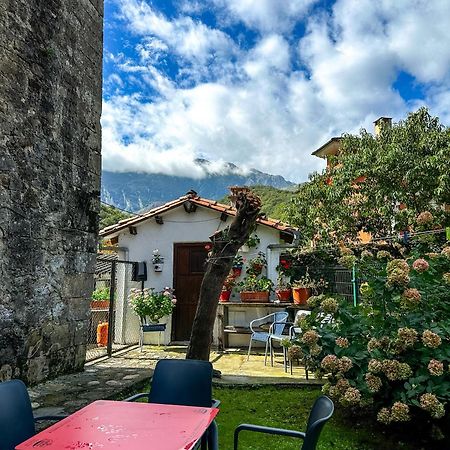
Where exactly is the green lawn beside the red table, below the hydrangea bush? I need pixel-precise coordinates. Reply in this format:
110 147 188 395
214 387 420 450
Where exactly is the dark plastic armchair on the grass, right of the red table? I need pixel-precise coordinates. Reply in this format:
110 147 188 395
234 395 334 450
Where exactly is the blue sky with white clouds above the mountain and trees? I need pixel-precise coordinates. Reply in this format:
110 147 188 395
102 0 450 182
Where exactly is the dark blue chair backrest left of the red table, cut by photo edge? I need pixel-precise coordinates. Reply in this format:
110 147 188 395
0 380 36 450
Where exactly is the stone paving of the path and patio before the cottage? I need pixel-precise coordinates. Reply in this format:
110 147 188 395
29 346 317 416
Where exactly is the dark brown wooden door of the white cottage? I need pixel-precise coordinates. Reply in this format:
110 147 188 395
172 243 208 341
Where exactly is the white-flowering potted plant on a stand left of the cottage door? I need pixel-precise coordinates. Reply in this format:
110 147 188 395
128 287 177 331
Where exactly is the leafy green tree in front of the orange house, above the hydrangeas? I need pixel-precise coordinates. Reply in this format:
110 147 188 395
287 108 450 248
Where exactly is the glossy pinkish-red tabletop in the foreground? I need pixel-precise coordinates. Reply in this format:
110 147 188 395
16 400 219 450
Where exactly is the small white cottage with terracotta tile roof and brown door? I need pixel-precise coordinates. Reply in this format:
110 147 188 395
100 192 295 344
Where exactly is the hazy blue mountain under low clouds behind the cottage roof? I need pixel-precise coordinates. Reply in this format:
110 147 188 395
101 160 295 212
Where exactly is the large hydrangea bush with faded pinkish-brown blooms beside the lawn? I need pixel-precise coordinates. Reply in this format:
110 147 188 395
285 242 450 436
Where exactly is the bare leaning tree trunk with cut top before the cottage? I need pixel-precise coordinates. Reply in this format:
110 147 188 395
186 191 261 361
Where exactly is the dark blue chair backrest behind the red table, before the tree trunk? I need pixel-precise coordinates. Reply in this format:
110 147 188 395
149 359 213 407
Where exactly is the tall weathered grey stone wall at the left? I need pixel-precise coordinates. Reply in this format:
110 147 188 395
0 0 103 384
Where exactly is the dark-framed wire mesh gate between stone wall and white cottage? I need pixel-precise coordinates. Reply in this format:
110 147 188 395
86 254 140 361
